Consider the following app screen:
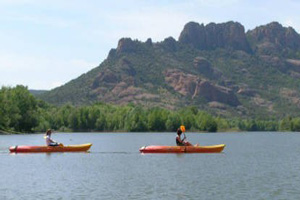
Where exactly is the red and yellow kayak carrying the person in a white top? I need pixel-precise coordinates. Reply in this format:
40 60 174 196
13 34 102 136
9 143 92 153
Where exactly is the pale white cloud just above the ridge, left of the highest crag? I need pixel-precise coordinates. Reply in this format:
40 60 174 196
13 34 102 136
101 4 190 41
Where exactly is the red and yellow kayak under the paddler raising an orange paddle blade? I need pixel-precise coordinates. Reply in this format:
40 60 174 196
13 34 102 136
140 144 225 153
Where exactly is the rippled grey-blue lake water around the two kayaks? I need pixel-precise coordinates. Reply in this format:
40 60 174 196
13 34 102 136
0 133 300 200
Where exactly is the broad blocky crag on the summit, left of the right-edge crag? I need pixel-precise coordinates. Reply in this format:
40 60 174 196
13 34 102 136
179 22 251 53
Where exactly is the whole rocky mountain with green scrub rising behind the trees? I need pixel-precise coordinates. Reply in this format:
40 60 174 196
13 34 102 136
39 22 300 118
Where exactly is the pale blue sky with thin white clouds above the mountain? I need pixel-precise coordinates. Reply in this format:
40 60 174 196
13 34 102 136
0 0 300 90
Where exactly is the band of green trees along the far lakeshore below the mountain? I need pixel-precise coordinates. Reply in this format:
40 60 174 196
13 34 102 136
0 85 300 133
